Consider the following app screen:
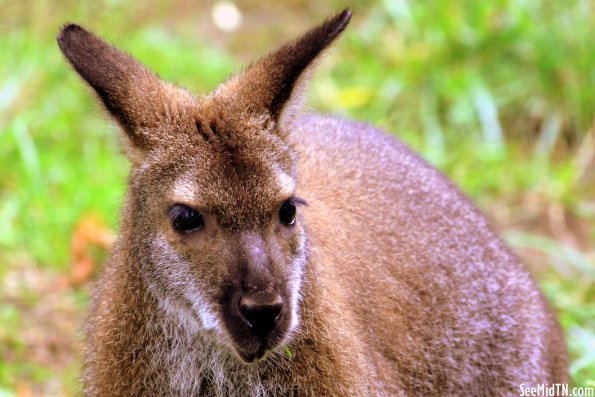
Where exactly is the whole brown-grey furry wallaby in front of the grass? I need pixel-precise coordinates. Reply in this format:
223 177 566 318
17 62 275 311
58 10 567 396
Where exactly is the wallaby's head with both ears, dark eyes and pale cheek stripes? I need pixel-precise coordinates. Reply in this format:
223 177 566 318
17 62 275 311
58 11 351 362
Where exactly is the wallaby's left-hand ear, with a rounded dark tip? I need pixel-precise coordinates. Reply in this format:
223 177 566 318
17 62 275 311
58 24 172 162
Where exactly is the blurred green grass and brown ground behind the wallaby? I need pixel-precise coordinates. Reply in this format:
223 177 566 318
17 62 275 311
0 0 595 397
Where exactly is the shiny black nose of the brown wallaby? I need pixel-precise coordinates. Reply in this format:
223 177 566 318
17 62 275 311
239 292 283 337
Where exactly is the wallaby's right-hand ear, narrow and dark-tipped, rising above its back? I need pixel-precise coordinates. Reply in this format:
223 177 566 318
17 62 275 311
216 9 351 128
